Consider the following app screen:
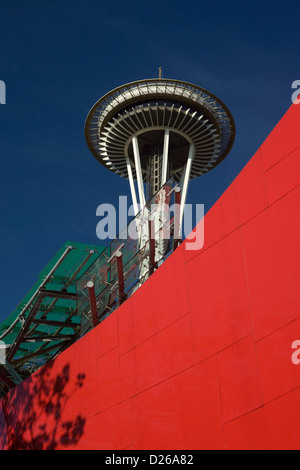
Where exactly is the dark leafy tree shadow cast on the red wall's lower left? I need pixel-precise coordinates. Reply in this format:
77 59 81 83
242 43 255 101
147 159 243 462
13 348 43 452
0 361 86 450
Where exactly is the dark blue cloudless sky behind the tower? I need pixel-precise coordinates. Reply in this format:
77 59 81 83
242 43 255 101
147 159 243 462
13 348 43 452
0 0 300 321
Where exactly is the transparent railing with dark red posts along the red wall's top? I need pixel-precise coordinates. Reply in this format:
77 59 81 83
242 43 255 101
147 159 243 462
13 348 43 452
76 179 181 335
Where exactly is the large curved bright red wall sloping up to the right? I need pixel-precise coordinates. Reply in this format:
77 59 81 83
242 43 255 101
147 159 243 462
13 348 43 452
0 105 300 450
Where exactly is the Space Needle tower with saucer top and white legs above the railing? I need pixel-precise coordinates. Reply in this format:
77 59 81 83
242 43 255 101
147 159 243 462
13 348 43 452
85 69 235 250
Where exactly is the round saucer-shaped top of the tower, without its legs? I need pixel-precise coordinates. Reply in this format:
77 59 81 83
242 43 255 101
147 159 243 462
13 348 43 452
85 79 235 181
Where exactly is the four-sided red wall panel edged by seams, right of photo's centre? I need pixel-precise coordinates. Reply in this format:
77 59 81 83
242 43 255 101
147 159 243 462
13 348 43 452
187 230 252 362
